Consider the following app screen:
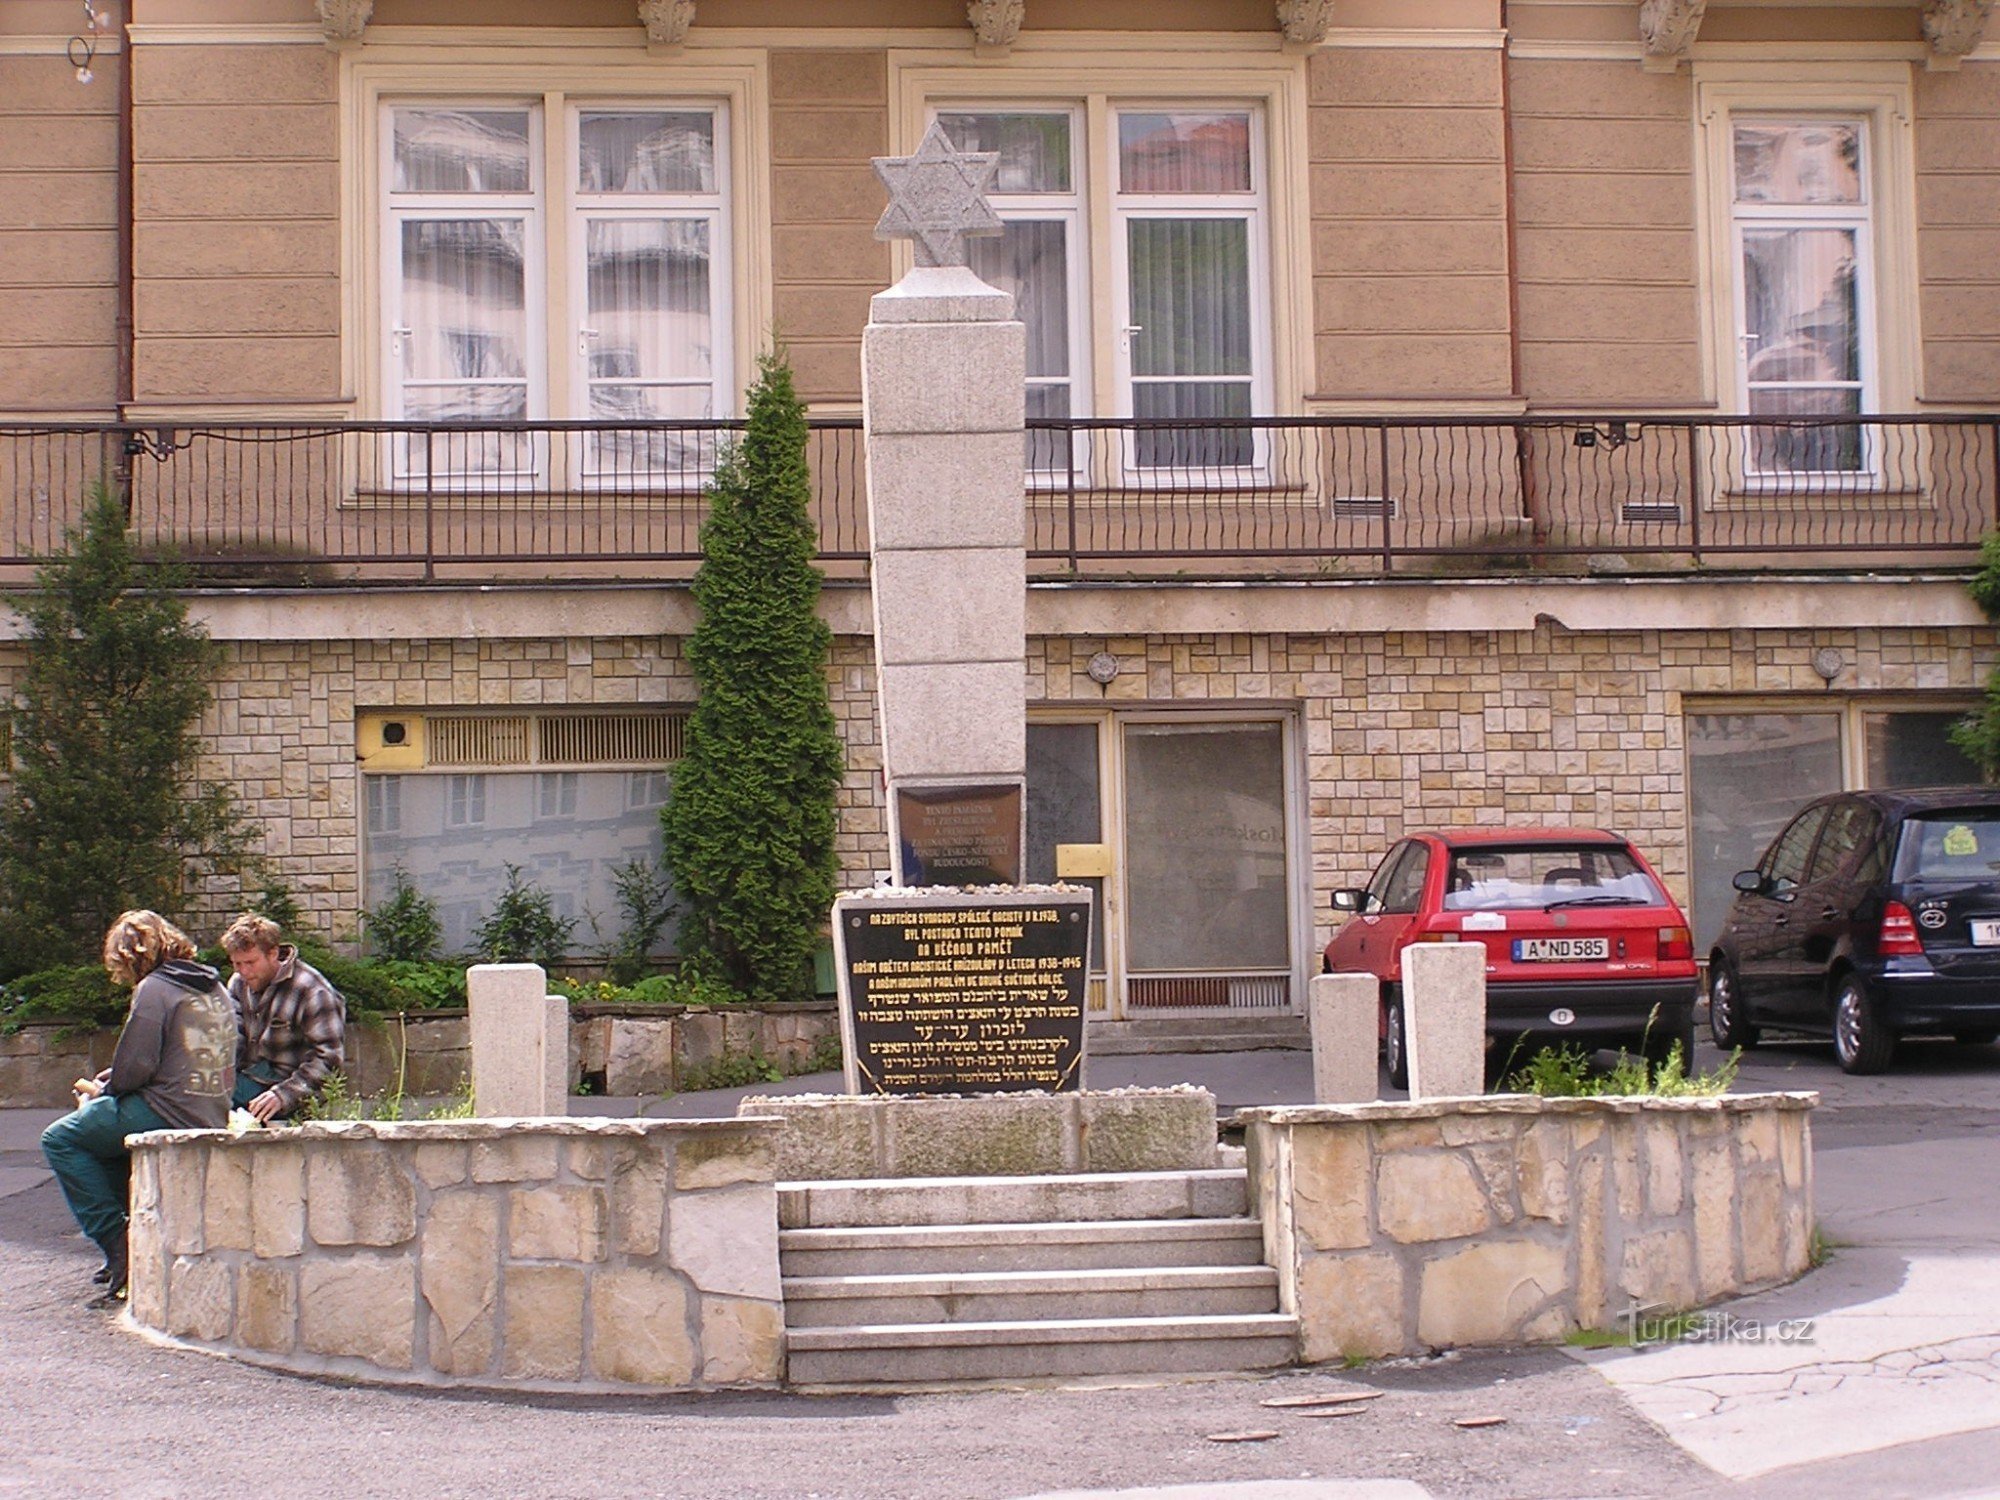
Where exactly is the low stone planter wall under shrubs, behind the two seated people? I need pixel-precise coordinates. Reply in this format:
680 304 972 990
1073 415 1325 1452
0 1000 840 1108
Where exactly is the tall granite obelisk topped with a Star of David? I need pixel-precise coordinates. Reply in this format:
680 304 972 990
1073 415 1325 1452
862 126 1028 886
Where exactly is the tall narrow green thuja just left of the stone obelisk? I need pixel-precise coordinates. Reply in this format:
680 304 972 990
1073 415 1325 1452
660 356 840 1000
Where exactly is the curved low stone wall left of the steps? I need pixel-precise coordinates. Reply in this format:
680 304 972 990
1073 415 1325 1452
130 1120 784 1390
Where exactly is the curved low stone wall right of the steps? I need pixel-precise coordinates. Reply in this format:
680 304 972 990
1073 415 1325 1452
1238 1094 1818 1364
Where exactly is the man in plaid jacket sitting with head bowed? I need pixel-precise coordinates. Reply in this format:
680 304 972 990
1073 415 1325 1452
222 912 348 1122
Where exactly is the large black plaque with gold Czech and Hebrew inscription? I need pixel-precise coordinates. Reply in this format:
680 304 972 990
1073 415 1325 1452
834 892 1090 1094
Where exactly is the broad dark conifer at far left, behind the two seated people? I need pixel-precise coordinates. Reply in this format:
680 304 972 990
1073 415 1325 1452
0 484 246 966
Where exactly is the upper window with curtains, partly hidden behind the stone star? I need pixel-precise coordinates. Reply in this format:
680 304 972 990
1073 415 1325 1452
938 104 1270 476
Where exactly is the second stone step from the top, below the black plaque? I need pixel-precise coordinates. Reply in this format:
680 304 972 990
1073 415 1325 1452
778 1218 1264 1278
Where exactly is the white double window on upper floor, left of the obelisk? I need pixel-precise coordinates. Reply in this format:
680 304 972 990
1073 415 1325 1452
382 100 732 480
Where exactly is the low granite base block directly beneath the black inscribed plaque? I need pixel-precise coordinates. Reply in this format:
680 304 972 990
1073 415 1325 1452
738 1086 1216 1182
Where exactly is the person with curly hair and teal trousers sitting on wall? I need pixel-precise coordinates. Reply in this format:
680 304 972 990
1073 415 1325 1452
42 912 236 1300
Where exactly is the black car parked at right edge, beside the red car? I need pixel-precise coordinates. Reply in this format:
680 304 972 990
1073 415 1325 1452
1708 786 2000 1072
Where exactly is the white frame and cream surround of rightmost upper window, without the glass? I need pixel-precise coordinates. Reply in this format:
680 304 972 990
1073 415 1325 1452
1694 62 1924 498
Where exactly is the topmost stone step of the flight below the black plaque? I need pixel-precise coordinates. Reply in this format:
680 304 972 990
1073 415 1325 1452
778 1168 1250 1230
